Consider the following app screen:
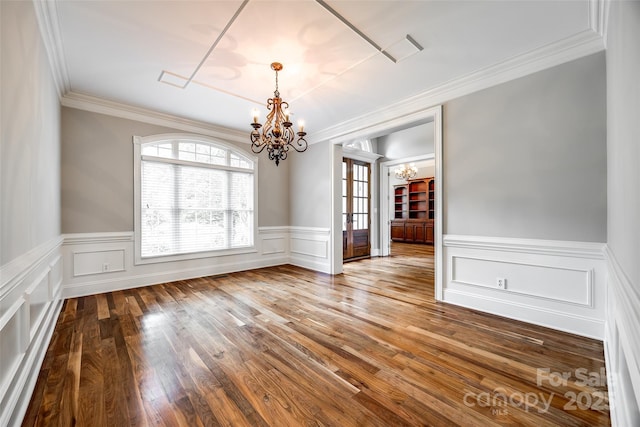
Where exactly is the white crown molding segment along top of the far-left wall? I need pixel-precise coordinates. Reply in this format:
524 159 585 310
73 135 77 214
33 0 71 98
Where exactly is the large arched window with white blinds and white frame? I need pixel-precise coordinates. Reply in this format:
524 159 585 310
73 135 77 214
134 134 257 264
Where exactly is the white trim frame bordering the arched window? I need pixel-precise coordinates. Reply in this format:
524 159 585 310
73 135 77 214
133 133 259 265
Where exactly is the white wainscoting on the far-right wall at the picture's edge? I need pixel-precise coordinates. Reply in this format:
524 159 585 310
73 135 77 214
604 248 640 426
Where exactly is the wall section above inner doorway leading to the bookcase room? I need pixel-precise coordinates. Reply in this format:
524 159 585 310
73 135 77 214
376 122 434 162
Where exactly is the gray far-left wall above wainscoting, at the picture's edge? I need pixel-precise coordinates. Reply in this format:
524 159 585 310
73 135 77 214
0 1 60 265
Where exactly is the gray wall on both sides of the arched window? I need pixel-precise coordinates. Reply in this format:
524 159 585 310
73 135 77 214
62 108 289 233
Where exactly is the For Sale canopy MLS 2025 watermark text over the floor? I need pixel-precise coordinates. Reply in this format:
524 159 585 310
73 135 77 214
462 368 609 416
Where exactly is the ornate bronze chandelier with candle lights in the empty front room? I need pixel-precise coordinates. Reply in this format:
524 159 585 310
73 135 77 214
251 62 307 166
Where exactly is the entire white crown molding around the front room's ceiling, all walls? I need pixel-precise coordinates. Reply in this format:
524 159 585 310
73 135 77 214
33 0 610 143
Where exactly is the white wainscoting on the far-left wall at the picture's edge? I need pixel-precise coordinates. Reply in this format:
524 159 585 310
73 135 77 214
0 237 62 426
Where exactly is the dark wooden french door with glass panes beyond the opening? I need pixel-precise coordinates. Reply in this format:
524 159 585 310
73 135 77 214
342 158 371 261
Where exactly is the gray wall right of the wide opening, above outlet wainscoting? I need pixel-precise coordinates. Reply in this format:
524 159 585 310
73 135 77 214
443 52 607 242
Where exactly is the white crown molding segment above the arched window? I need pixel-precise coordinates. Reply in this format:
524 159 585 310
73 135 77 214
60 92 249 144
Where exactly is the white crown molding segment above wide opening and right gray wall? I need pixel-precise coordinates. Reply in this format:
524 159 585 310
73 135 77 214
314 20 604 143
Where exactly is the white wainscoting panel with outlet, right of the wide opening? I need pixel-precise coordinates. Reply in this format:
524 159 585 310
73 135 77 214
443 235 607 340
